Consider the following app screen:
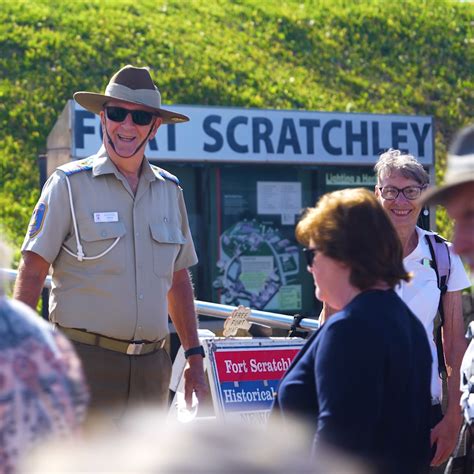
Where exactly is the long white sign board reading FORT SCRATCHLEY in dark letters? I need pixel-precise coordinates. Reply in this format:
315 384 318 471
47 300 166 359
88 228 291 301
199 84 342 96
69 101 434 165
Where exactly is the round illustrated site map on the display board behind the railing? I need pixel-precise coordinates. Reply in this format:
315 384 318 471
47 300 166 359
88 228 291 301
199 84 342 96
213 219 301 310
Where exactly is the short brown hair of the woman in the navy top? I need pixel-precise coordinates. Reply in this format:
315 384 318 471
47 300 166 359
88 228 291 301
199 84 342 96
296 188 410 290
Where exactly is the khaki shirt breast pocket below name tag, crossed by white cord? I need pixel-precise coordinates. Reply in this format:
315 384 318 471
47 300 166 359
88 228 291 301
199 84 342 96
61 222 126 275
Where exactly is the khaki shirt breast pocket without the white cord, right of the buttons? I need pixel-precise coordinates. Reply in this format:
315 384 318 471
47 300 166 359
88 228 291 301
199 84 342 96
150 224 186 277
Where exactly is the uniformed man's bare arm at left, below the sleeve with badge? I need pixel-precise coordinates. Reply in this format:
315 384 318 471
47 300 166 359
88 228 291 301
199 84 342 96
13 251 50 310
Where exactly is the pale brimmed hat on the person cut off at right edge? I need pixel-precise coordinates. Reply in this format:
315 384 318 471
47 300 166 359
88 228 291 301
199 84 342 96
423 125 474 204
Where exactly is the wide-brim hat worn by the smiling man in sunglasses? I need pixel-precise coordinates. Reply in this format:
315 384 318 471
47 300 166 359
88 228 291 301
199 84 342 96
74 65 189 123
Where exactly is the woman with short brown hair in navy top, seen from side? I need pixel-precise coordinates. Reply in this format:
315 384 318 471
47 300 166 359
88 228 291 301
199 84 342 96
273 189 431 474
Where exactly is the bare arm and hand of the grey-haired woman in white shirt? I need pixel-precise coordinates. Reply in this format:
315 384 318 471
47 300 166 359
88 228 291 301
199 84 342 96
431 291 467 466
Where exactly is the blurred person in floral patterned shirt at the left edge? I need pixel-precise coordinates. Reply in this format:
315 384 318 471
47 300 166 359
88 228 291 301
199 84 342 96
0 242 88 473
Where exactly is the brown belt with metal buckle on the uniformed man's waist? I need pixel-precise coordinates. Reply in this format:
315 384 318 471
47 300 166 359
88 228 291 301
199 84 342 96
56 325 166 355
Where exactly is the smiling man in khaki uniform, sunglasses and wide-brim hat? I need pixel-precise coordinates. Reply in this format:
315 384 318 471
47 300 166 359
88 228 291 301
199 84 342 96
14 66 207 416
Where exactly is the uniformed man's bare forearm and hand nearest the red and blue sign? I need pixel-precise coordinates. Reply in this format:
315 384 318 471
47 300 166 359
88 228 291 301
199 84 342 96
168 269 208 407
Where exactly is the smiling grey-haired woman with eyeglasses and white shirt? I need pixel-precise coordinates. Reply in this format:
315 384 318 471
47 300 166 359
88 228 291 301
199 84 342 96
375 150 469 466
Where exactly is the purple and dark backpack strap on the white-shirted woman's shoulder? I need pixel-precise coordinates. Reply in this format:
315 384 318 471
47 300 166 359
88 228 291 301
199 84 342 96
425 234 451 378
